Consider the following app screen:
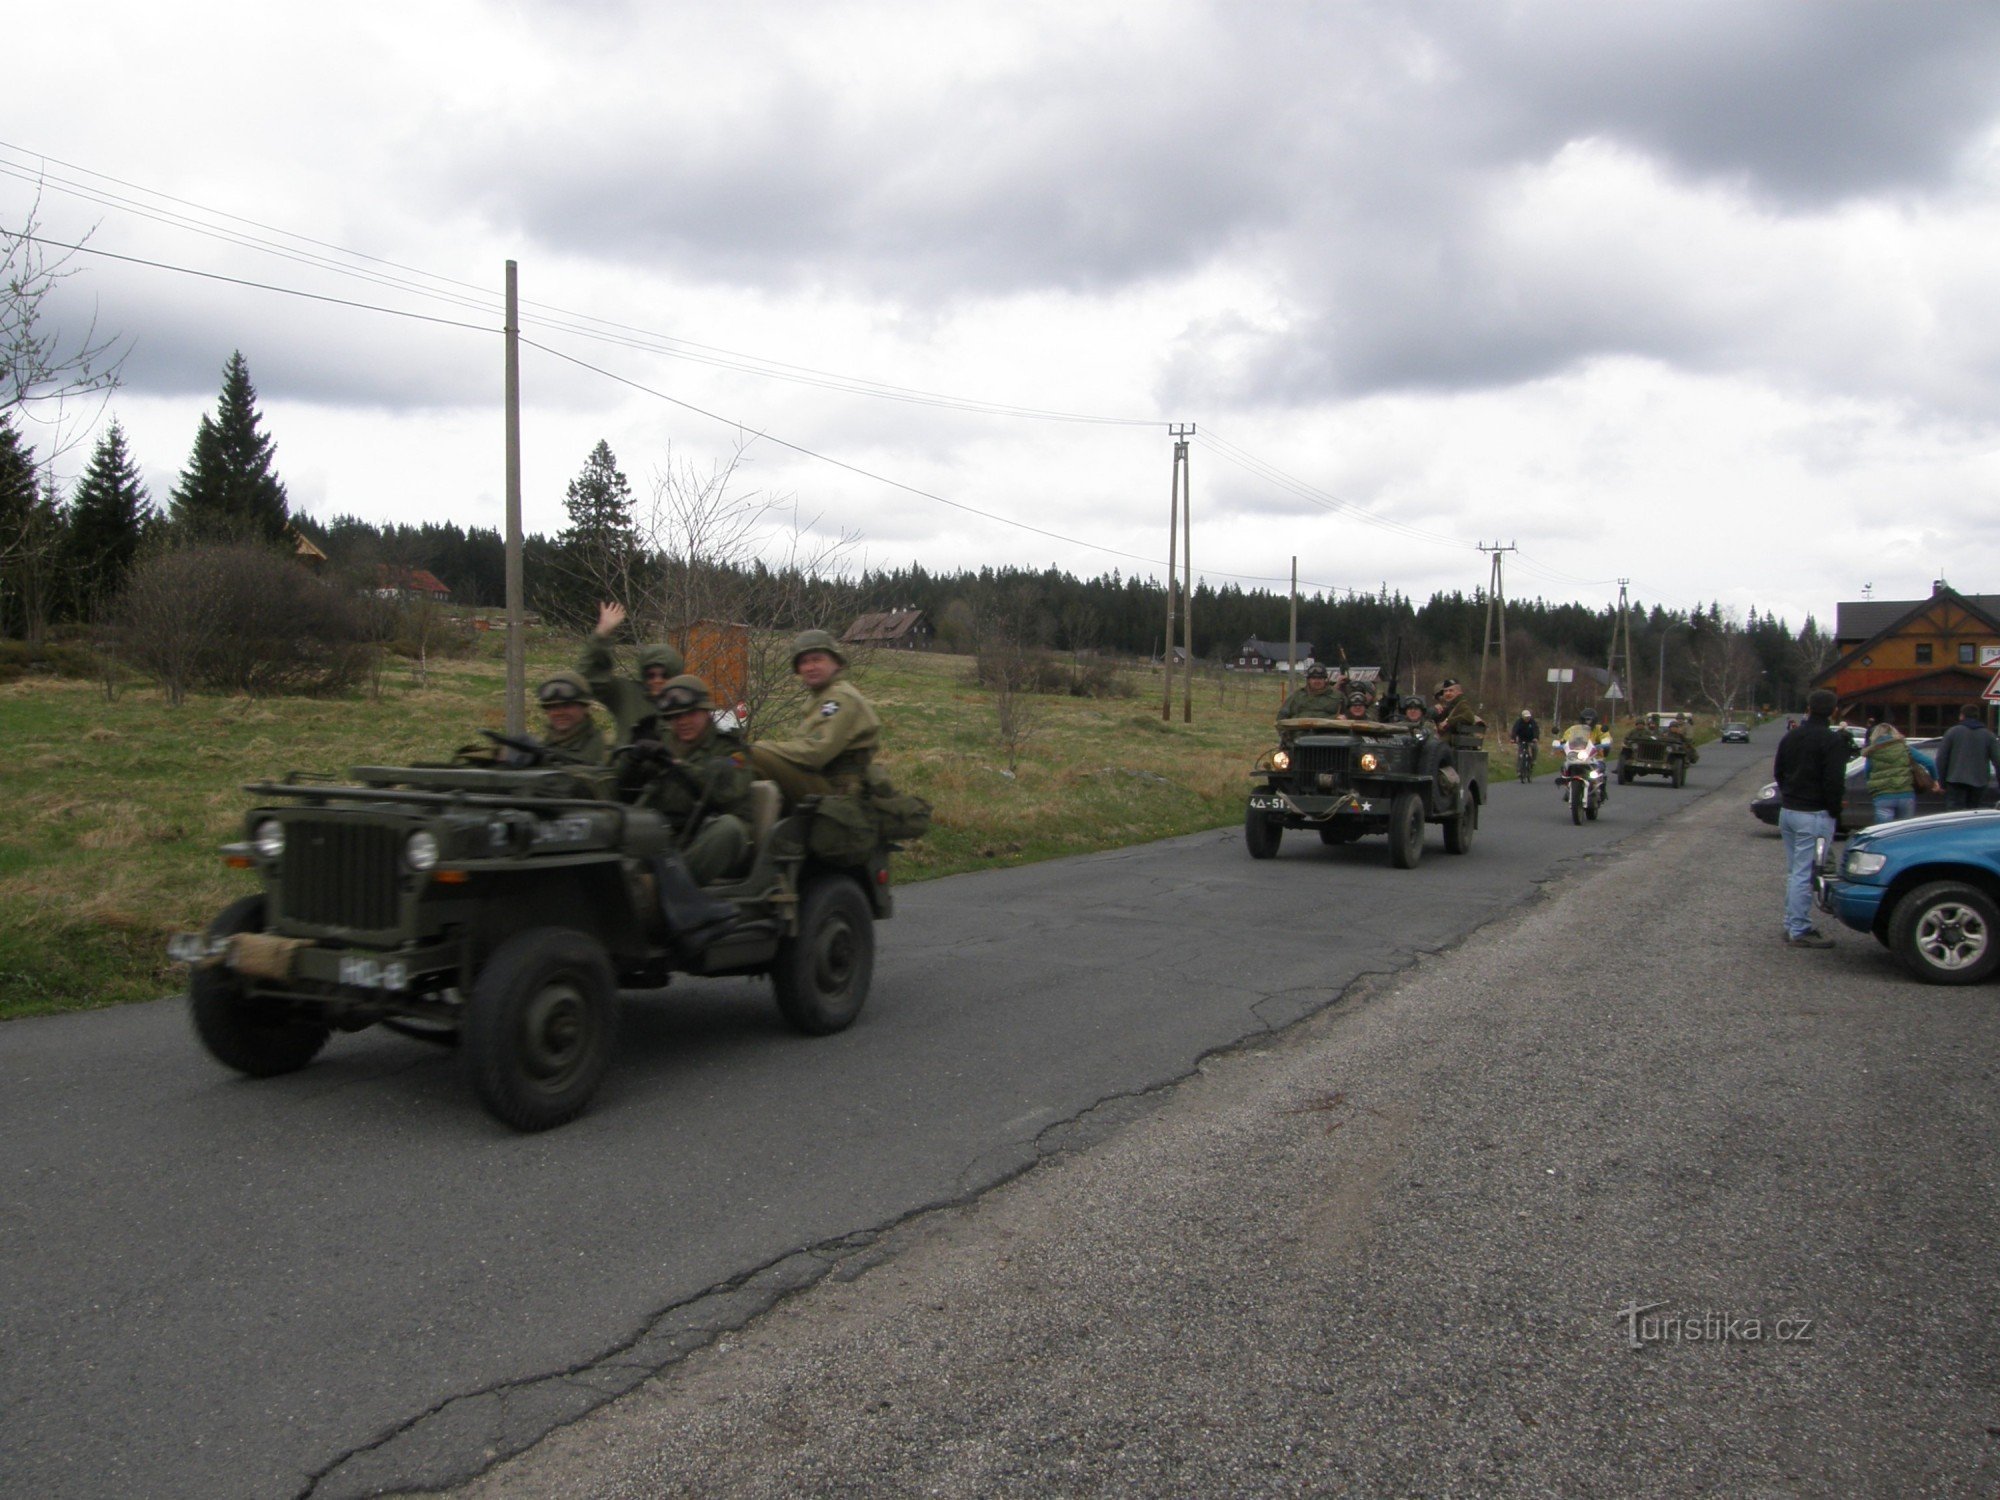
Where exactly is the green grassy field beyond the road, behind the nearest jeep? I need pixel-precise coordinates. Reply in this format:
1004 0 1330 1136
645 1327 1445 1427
0 638 1280 1018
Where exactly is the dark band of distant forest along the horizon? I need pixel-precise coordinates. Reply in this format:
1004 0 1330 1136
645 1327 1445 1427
294 516 1834 712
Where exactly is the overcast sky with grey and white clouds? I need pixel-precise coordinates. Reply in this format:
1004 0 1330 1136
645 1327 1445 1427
0 0 2000 626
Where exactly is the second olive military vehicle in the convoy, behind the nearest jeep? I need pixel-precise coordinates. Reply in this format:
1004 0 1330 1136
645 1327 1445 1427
1244 718 1486 870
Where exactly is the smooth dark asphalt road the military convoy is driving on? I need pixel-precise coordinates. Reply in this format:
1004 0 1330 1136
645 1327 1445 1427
0 744 1774 1498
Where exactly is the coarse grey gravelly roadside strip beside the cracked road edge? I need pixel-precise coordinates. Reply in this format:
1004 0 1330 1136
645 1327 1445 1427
438 756 2000 1500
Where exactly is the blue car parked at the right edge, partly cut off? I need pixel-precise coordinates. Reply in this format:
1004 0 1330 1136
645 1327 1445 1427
1818 812 2000 984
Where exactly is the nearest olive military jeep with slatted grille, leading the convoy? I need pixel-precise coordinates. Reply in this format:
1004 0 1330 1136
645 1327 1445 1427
172 766 892 1130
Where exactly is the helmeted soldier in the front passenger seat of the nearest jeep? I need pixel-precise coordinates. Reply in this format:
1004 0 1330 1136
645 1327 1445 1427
624 676 756 886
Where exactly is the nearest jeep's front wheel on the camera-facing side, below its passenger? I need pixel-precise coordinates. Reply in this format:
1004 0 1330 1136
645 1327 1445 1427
458 928 618 1130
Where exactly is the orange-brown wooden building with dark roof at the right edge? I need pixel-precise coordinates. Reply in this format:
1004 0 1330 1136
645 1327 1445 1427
1812 580 2000 736
